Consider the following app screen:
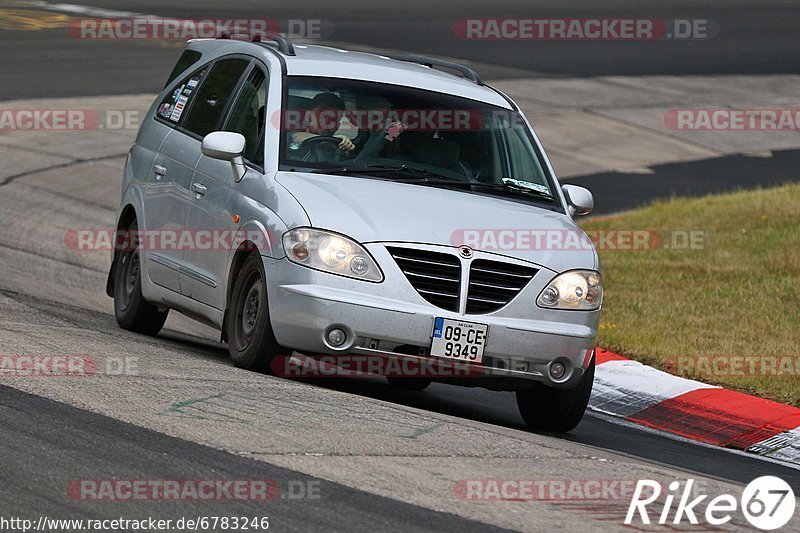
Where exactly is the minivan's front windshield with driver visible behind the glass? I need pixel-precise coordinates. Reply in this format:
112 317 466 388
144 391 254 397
280 76 557 205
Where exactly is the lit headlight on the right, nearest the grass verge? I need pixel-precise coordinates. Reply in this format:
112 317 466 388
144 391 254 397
536 270 603 311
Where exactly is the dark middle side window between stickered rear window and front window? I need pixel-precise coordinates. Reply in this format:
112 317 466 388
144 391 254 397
183 59 250 137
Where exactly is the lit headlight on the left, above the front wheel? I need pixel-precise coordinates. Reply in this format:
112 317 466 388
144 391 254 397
283 228 383 281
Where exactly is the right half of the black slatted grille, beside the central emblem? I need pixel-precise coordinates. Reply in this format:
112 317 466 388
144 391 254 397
467 259 537 314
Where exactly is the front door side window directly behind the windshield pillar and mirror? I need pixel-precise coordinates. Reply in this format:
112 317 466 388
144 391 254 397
223 68 267 165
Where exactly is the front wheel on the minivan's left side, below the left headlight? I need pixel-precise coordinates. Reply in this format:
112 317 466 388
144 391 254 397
225 253 286 374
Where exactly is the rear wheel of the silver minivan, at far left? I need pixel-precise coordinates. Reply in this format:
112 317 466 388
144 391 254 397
114 220 169 335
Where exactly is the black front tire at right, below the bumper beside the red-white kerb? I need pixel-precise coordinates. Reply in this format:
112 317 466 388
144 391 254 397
517 357 594 433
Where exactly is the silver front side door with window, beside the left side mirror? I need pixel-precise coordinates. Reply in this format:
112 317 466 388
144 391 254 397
181 63 268 310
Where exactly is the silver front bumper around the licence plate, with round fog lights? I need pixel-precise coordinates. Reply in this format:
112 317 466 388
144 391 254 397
264 244 599 390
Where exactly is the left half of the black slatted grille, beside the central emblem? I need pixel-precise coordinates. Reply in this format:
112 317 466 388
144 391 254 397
388 247 461 311
